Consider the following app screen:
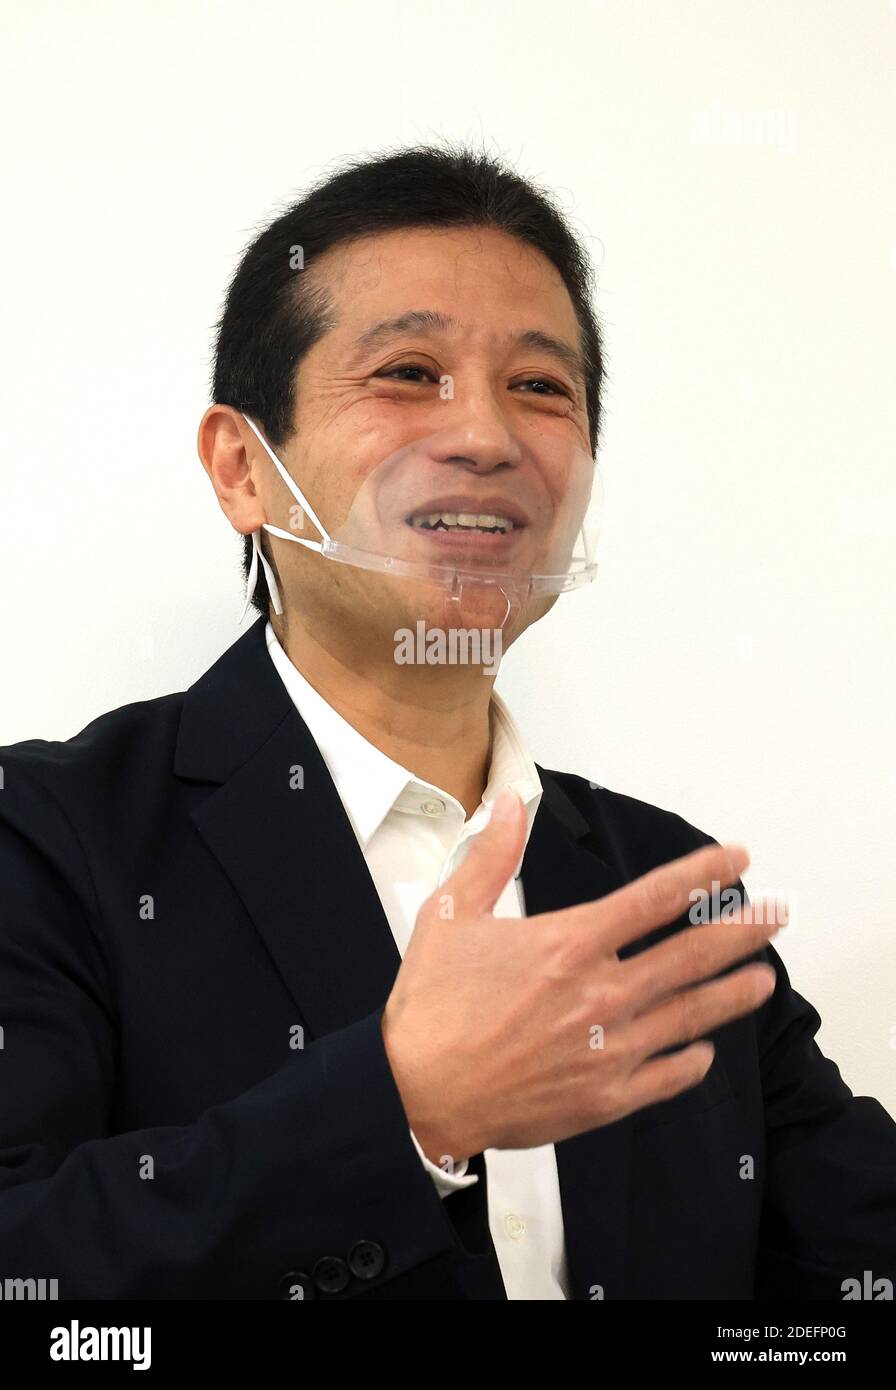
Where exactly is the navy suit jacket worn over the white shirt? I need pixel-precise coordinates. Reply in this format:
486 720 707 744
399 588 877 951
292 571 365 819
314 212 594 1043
0 619 896 1300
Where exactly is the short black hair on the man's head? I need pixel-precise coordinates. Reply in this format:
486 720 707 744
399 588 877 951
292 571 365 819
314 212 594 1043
211 143 603 616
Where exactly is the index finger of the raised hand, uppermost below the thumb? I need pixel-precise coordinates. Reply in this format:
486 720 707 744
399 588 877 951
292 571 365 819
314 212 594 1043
565 845 750 955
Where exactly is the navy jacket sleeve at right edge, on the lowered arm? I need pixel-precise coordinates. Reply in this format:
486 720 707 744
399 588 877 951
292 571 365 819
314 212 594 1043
756 947 896 1300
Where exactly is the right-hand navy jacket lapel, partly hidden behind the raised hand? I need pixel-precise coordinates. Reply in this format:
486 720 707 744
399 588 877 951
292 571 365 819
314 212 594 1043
522 767 632 1300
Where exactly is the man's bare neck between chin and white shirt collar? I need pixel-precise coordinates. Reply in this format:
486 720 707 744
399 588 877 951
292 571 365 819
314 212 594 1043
271 614 495 816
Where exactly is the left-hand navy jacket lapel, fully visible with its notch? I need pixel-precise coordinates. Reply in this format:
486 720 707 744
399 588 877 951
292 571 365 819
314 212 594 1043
175 619 400 1037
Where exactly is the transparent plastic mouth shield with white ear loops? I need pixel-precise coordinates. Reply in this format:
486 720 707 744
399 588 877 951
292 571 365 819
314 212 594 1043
243 416 603 627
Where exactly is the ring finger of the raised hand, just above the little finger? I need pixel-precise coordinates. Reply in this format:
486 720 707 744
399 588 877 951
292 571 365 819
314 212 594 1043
617 963 777 1058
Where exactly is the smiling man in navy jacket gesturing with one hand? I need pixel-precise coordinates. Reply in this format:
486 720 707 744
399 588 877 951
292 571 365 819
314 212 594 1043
0 149 896 1300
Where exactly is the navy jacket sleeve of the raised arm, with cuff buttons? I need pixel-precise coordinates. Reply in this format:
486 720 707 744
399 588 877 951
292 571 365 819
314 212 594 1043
0 774 457 1298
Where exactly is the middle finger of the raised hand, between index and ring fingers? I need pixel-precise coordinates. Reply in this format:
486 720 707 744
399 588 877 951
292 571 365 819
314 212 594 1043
620 898 786 1015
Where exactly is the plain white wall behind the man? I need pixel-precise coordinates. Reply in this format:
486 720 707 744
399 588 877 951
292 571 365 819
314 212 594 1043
0 0 896 1113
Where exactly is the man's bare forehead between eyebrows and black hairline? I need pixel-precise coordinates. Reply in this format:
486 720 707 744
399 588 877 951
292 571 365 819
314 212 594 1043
308 227 579 343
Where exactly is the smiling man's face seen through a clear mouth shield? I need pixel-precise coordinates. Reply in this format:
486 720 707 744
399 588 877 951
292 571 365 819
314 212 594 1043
251 228 592 652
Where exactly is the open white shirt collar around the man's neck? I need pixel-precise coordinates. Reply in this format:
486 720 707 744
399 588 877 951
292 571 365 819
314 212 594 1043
265 623 542 849
